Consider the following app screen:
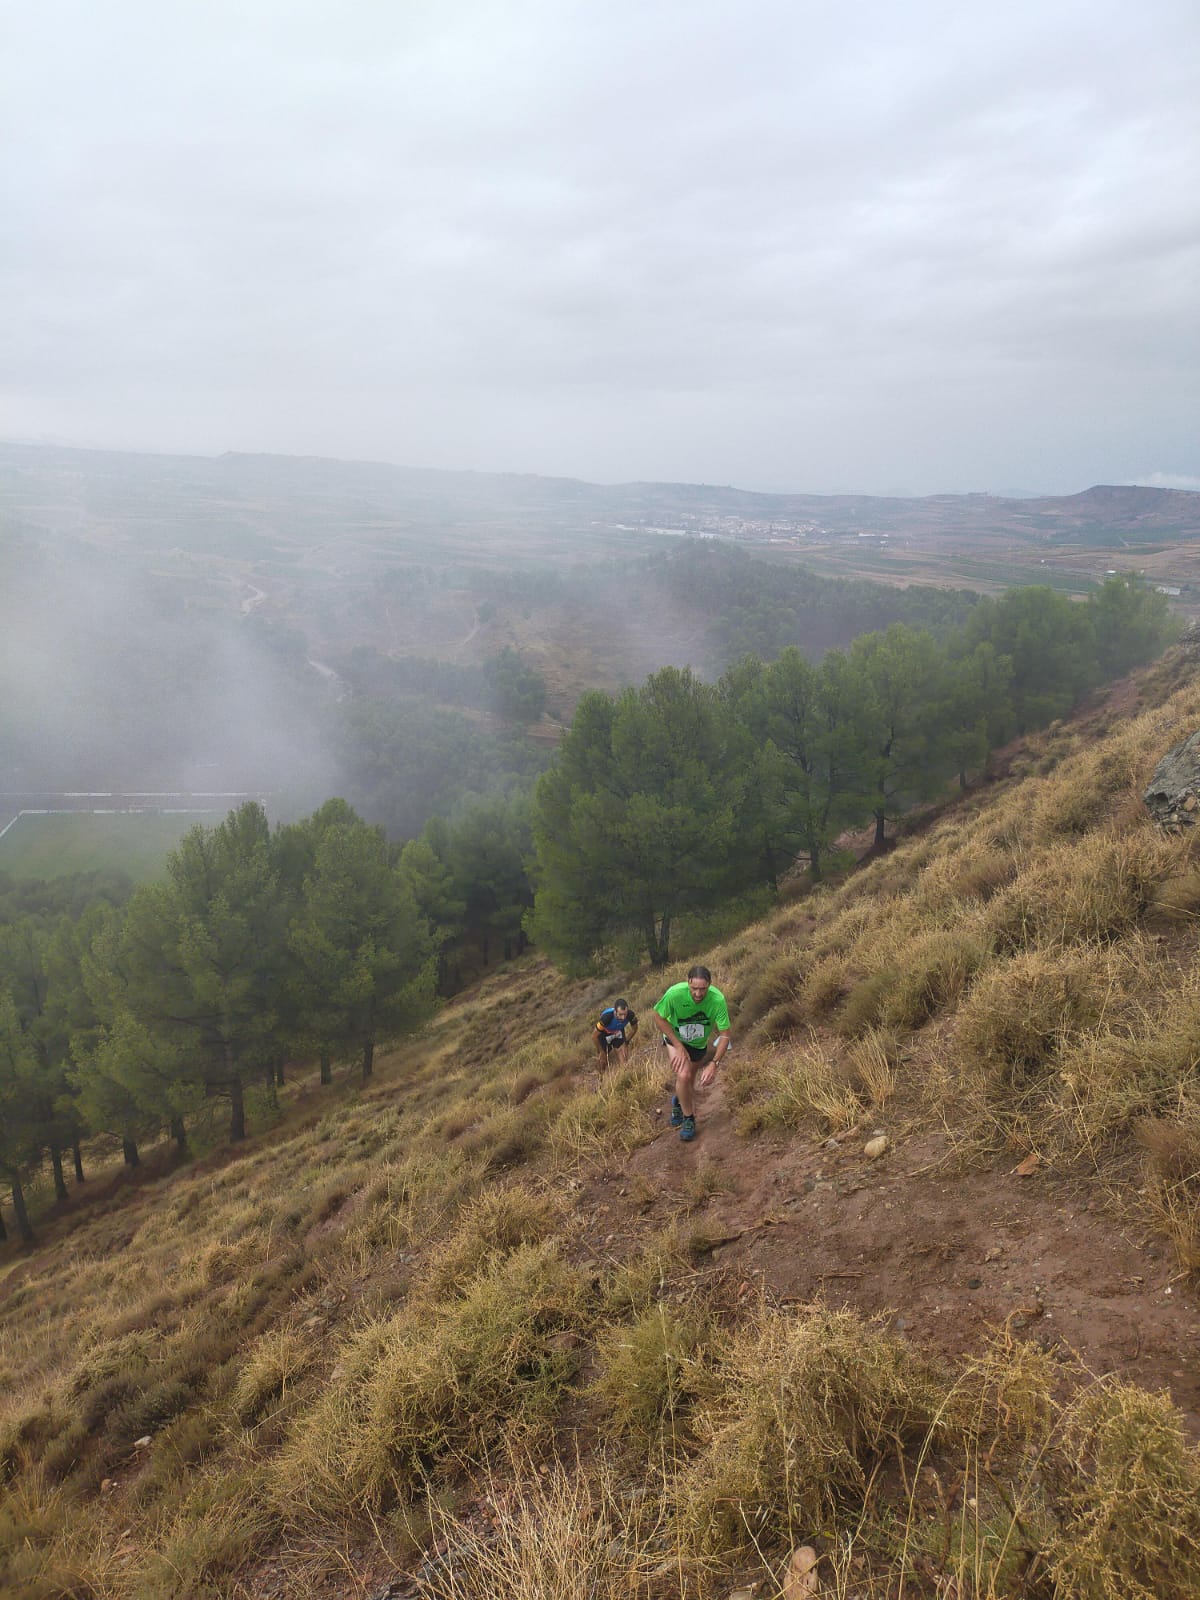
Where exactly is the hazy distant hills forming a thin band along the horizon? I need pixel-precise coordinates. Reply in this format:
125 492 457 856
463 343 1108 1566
0 443 1200 546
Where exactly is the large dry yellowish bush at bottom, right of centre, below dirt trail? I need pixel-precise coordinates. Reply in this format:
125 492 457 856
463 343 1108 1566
672 1307 942 1555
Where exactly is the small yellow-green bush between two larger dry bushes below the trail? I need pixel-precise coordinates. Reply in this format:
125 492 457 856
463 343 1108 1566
589 1304 712 1450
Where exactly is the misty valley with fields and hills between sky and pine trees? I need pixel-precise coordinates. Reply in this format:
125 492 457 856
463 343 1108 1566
0 445 1200 864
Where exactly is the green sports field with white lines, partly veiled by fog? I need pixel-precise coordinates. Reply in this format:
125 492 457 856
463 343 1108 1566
0 811 211 882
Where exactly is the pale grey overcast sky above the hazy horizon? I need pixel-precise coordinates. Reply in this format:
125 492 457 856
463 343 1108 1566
0 0 1200 494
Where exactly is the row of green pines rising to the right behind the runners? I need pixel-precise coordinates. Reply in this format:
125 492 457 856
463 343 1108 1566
528 578 1171 970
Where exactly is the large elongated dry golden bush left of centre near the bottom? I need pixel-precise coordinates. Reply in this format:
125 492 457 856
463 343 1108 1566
274 1243 587 1523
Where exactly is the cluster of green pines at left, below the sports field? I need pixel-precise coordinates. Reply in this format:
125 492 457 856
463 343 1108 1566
0 797 531 1238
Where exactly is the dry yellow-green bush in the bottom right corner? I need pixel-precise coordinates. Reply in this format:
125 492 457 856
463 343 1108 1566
1050 1379 1200 1600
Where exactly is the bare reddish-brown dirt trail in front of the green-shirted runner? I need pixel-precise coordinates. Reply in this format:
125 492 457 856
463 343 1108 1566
581 1062 1200 1437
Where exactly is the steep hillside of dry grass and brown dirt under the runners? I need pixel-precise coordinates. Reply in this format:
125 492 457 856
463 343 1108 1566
0 658 1200 1600
